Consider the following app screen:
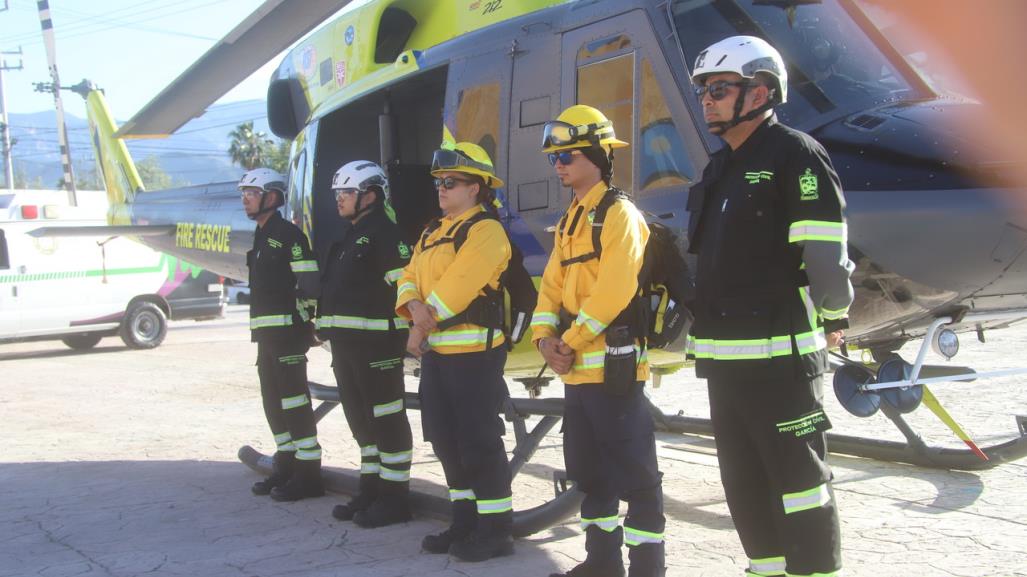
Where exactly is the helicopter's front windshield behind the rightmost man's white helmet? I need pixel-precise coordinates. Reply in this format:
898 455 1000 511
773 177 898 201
672 0 927 126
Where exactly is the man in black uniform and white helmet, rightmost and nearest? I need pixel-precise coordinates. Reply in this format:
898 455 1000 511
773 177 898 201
688 36 853 577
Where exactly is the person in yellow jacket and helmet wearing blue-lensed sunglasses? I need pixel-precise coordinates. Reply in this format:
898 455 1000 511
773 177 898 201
531 105 664 577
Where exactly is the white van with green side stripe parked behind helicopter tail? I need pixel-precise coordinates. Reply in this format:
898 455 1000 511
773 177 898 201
0 191 225 349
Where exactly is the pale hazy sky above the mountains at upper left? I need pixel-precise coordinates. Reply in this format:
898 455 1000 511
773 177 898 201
0 0 364 120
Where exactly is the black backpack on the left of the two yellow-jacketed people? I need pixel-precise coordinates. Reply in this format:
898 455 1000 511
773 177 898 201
421 210 538 349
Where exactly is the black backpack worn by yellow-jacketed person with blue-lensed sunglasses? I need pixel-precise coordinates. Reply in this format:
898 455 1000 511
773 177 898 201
560 187 695 349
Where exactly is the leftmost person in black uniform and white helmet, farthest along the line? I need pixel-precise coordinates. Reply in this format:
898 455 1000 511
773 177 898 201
239 168 325 501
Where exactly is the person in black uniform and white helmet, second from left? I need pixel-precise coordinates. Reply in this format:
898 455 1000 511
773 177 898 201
317 160 413 528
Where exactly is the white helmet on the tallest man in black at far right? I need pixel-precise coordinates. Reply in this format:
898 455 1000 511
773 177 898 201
692 36 788 104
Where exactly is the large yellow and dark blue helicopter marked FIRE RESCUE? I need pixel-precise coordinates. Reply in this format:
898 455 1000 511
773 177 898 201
36 0 1027 534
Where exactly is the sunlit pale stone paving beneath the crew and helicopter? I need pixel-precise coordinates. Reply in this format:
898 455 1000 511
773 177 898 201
0 308 1027 577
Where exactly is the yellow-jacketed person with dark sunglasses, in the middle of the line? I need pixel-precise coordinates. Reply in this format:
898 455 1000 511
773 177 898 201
395 143 514 562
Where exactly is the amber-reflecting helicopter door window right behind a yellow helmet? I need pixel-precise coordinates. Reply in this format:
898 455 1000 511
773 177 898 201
577 51 635 190
